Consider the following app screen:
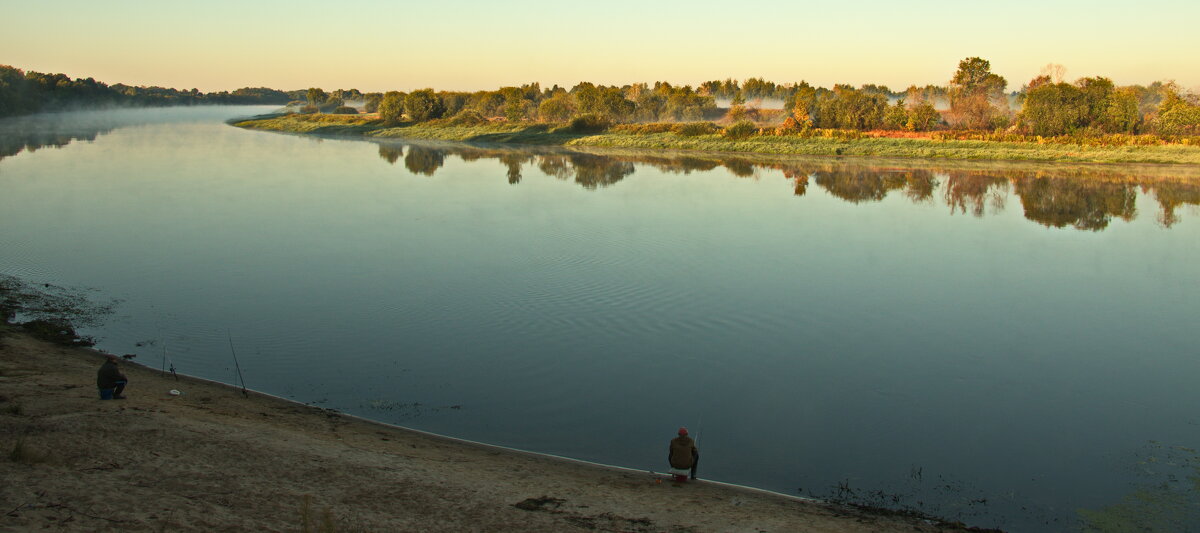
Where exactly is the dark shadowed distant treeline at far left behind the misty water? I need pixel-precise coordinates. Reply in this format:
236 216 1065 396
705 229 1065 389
0 65 297 116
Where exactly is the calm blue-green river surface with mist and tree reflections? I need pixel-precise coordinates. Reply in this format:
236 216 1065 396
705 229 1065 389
0 108 1200 531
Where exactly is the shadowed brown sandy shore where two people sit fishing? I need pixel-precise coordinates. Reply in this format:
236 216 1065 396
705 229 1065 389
0 325 984 533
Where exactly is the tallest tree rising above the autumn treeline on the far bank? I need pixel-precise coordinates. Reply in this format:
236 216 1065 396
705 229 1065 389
950 58 1008 130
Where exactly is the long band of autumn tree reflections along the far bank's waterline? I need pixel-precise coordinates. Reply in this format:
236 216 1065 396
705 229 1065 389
379 144 1200 232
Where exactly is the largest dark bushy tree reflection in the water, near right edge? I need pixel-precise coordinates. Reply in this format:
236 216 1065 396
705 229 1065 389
1015 178 1138 232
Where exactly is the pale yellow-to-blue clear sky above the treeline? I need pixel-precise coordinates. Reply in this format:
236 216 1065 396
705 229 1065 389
0 0 1200 92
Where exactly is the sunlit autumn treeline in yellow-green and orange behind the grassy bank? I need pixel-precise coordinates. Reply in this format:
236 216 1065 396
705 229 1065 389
302 58 1200 137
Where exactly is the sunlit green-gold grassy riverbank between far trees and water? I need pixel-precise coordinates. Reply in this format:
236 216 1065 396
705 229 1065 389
234 114 1200 164
